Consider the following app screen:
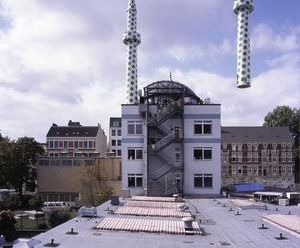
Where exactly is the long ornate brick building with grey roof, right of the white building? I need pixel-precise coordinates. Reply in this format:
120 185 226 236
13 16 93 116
222 127 295 188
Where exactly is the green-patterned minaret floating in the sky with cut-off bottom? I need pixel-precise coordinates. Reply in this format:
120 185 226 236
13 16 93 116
233 0 254 88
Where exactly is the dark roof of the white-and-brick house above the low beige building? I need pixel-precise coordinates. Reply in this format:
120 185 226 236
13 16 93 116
47 126 101 137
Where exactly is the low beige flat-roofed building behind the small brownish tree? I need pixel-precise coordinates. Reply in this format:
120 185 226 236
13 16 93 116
37 157 121 202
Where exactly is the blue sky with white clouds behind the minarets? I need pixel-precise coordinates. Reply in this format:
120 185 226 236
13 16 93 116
0 0 300 142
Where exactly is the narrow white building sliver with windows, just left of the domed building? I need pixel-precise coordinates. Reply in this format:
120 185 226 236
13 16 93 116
108 117 122 157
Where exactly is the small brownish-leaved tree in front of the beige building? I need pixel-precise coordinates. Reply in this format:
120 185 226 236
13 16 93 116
80 160 112 206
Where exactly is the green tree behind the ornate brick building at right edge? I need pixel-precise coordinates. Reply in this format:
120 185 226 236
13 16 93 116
263 106 300 182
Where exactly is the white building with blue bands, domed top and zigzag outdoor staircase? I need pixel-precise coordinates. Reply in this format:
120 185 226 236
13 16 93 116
122 81 221 195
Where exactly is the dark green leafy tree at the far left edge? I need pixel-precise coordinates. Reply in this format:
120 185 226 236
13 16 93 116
0 137 44 199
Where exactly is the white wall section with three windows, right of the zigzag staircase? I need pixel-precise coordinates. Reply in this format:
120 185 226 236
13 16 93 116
184 105 221 194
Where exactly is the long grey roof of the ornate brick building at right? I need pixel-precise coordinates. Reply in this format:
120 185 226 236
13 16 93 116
221 127 292 142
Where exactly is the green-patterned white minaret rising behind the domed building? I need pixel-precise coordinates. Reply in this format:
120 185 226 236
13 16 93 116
123 0 141 104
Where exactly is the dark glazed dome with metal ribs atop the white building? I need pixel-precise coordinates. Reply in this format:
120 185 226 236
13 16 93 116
144 81 202 104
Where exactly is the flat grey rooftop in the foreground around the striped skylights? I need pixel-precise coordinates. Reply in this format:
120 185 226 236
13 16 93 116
25 198 300 248
